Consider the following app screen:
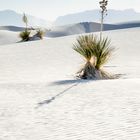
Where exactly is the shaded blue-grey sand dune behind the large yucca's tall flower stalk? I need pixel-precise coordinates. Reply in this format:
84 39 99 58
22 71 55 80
46 22 140 37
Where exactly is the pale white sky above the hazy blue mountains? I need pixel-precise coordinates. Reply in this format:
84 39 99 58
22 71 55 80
0 0 140 21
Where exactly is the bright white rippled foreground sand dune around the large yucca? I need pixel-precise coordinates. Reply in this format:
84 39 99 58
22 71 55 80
0 28 140 140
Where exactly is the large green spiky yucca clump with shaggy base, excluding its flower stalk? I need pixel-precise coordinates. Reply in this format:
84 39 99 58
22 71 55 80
73 35 114 79
